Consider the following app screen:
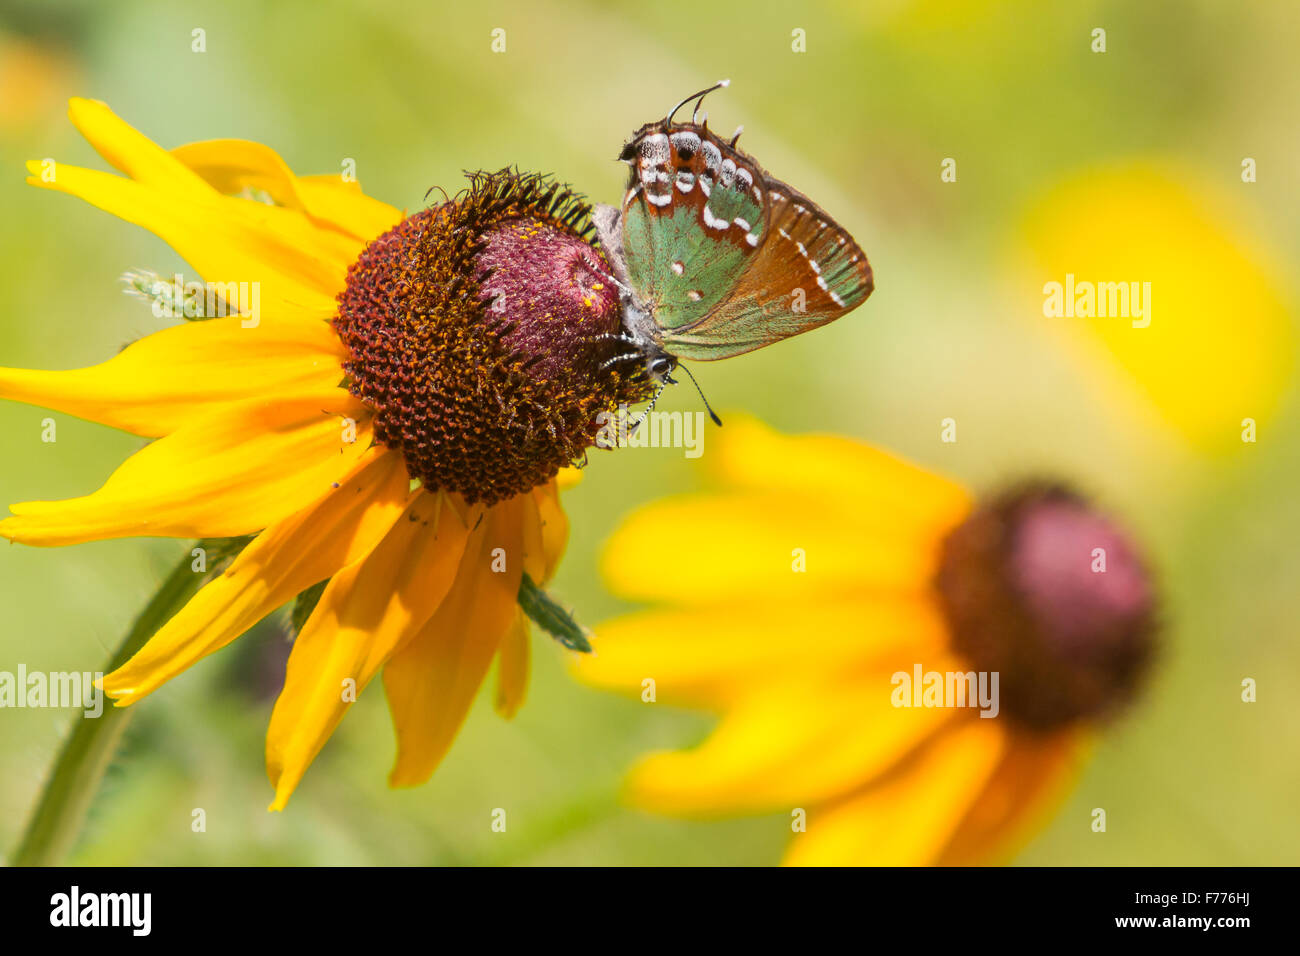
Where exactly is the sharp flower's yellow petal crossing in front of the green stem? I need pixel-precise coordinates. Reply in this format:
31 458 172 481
104 446 410 706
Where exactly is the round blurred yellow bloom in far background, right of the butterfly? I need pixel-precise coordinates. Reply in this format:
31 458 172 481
1019 164 1296 453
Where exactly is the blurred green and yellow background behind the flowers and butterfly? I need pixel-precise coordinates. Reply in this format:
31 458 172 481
0 0 1300 865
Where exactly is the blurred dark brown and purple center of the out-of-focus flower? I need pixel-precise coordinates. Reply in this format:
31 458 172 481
937 485 1156 731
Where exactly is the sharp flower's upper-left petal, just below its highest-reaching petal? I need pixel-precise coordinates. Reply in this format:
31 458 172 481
27 161 348 321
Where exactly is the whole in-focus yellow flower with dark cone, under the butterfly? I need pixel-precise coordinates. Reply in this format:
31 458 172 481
0 100 647 809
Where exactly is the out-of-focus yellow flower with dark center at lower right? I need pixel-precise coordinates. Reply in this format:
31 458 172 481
575 420 1154 865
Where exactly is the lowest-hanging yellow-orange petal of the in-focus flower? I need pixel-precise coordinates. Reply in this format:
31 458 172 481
267 493 473 810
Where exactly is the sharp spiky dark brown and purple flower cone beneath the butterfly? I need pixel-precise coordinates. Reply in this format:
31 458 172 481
334 170 650 503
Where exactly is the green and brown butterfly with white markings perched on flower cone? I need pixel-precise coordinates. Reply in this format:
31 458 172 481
592 79 874 390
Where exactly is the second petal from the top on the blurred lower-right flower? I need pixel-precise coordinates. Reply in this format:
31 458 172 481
601 492 940 605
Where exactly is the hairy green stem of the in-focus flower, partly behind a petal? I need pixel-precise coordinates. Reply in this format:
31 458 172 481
10 542 226 866
